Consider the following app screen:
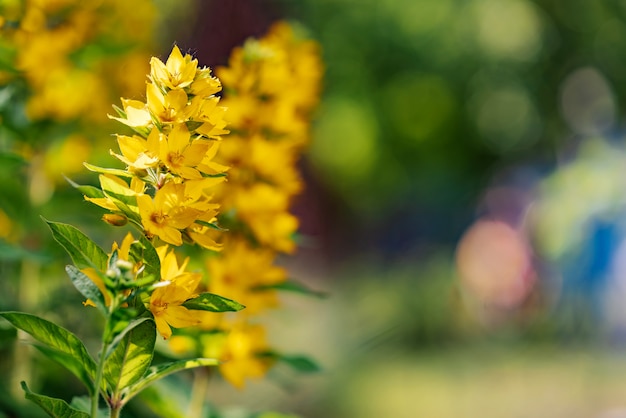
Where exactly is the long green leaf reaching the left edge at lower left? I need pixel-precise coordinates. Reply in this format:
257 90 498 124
0 312 96 393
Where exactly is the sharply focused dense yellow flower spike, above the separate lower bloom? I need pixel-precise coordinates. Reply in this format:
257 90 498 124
86 46 227 250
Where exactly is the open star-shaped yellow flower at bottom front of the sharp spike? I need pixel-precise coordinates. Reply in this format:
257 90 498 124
137 182 202 246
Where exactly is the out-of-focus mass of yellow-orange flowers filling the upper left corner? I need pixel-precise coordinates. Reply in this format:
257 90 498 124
0 0 156 206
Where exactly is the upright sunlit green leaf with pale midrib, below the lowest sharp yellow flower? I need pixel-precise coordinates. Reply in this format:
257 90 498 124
104 320 156 393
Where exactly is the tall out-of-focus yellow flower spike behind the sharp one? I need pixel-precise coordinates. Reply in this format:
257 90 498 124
172 22 322 387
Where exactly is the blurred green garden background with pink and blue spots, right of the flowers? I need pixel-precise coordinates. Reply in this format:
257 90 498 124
8 0 626 418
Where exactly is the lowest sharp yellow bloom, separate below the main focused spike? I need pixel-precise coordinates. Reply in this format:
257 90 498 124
148 246 202 339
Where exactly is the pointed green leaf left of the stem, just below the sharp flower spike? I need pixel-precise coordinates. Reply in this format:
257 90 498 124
42 218 108 271
